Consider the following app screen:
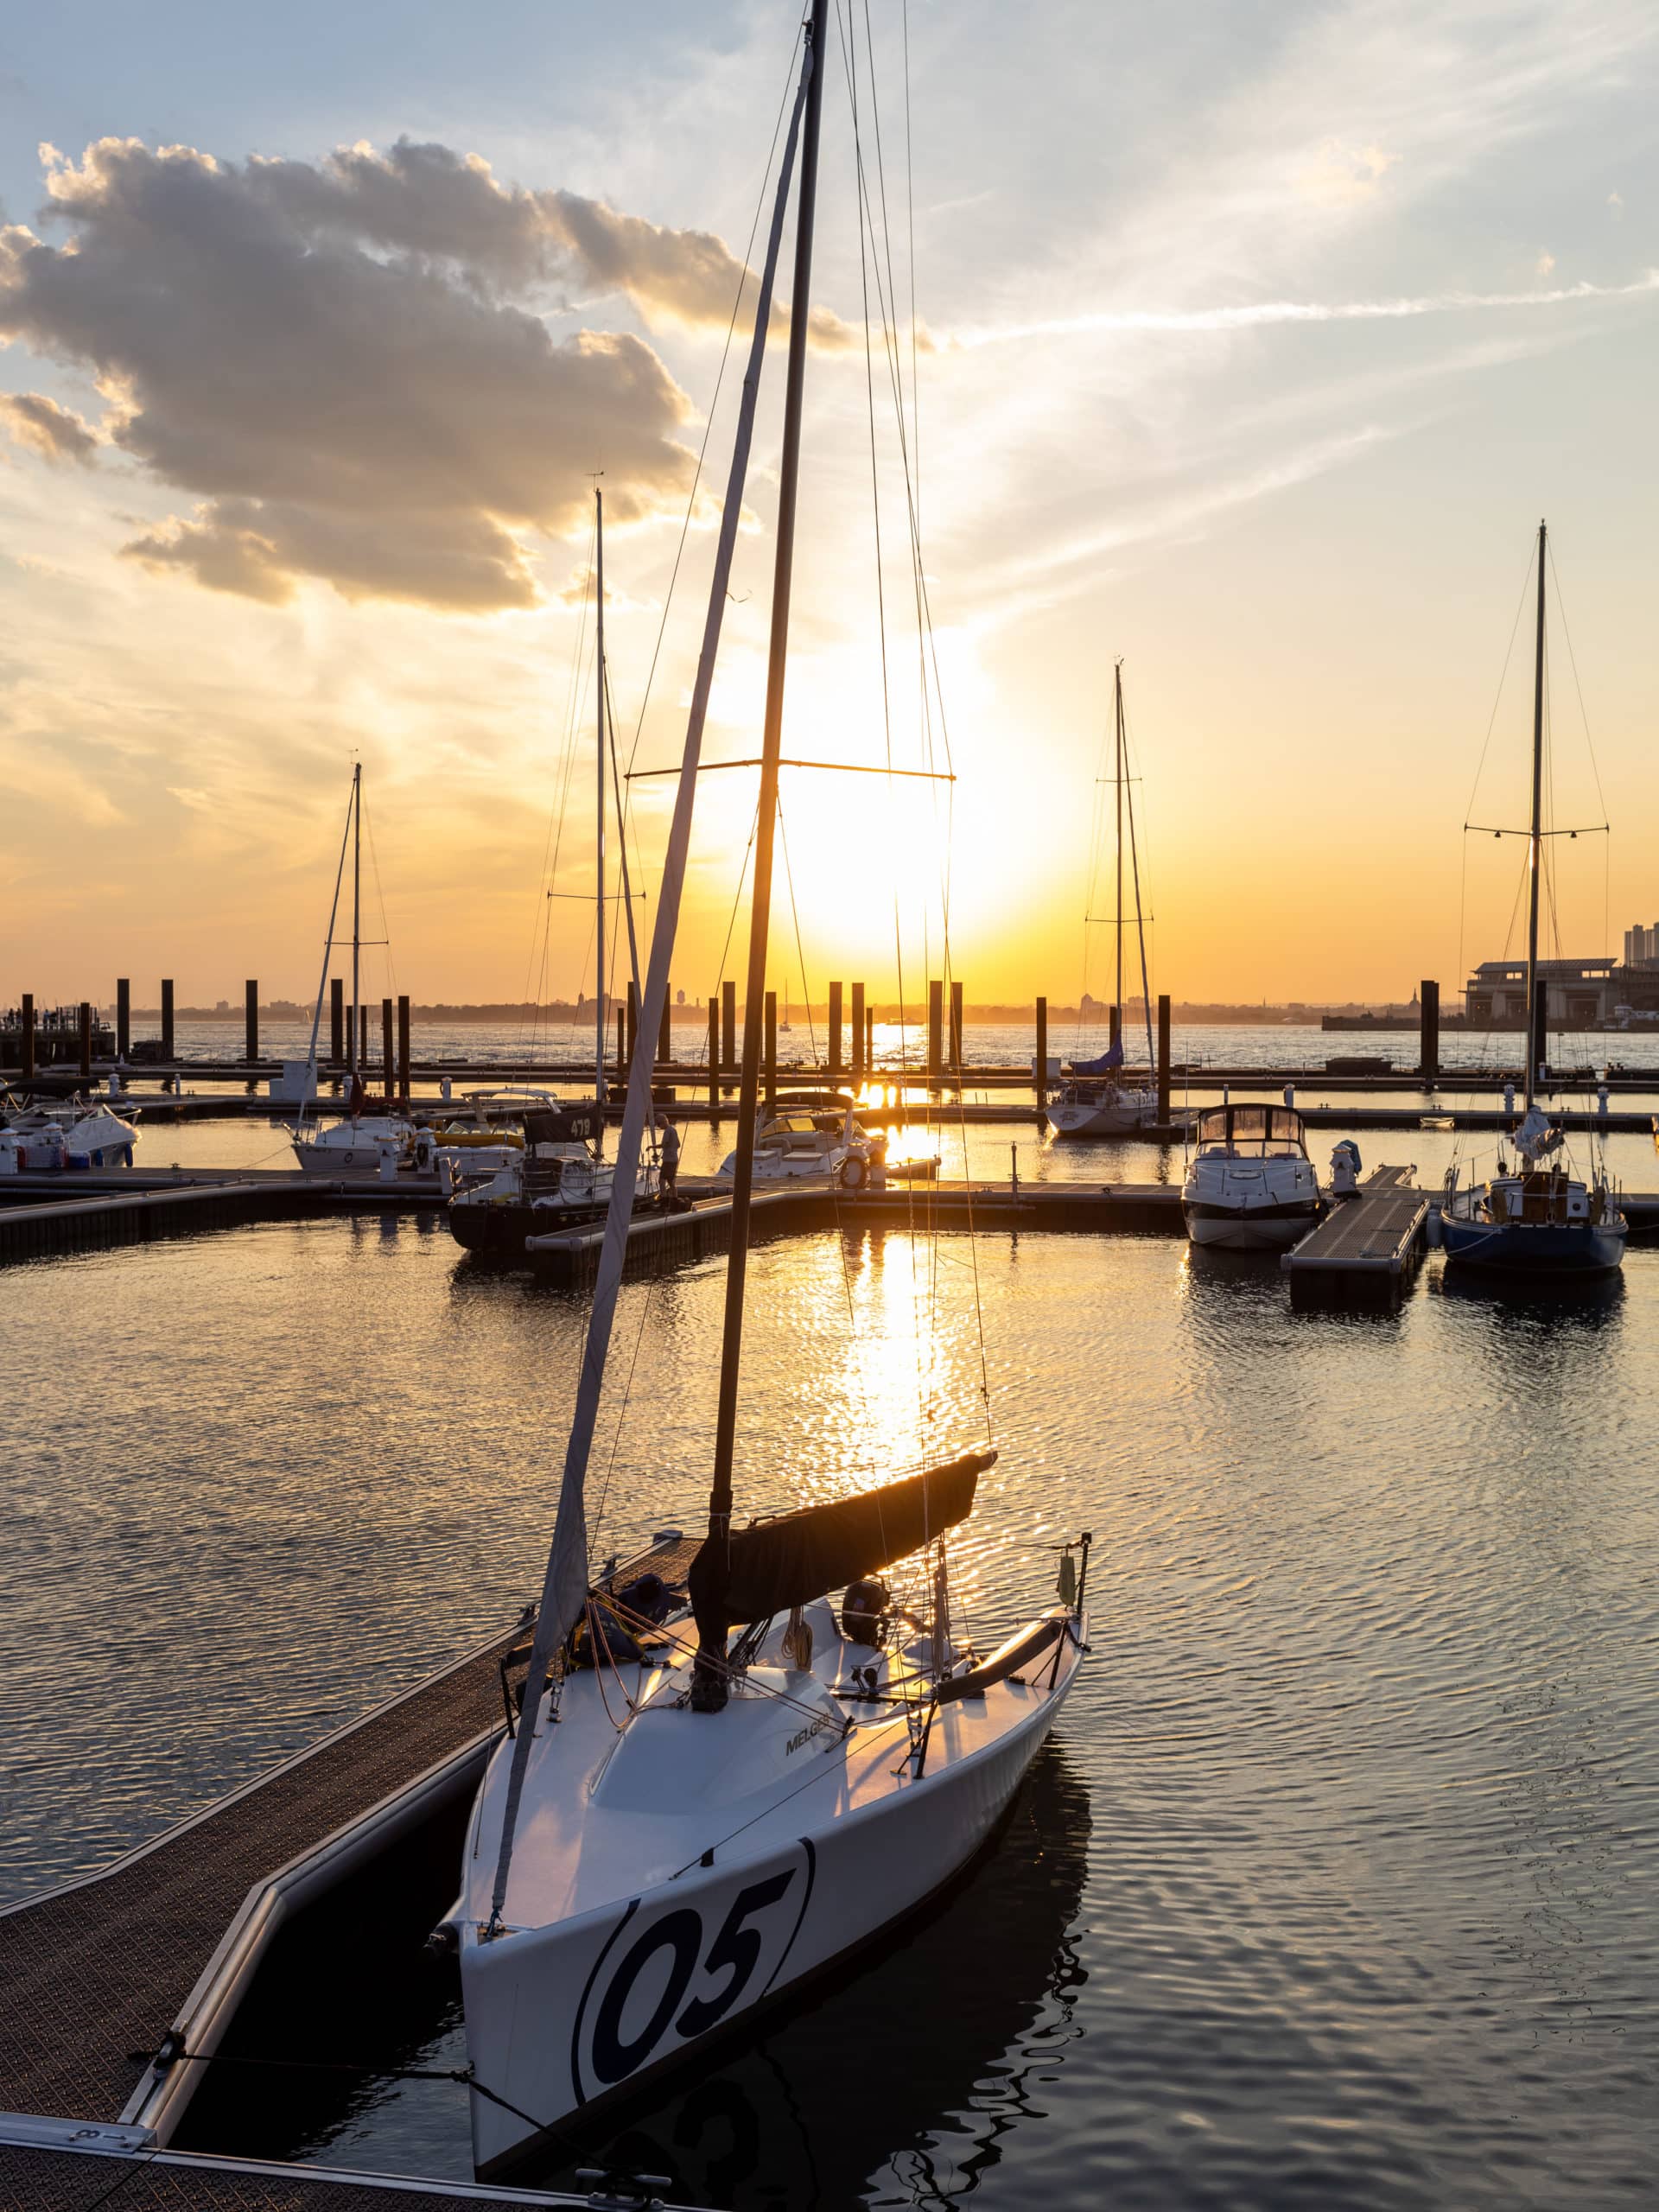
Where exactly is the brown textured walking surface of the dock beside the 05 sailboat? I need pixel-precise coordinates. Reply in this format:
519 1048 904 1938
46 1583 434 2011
0 1630 522 2123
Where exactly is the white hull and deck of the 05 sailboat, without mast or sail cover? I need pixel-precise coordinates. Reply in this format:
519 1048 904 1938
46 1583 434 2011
454 1601 1086 2177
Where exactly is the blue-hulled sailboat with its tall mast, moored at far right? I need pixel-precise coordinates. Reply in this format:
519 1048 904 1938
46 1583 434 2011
1440 522 1630 1276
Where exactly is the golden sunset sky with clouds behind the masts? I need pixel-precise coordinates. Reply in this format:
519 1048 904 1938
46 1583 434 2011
0 0 1659 1002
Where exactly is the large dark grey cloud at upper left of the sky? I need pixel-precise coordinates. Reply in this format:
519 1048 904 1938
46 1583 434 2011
0 139 827 611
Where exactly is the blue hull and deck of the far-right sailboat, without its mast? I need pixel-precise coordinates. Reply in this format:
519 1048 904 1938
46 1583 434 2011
1440 1106 1630 1274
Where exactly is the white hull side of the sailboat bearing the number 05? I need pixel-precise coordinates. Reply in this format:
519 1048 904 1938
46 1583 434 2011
460 1628 1082 2179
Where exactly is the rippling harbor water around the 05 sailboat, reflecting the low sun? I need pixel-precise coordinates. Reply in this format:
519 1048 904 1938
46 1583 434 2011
0 1048 1659 2212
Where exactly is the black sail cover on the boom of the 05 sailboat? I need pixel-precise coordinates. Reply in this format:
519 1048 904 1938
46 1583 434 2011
686 1451 998 1652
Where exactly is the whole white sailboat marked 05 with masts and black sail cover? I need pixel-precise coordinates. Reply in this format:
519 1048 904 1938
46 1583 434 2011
447 0 1086 2174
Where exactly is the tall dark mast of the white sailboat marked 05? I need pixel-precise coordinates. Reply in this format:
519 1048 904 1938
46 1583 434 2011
708 0 830 1592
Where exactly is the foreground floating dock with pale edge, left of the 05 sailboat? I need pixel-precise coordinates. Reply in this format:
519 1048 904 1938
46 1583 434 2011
0 1546 712 2212
